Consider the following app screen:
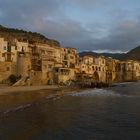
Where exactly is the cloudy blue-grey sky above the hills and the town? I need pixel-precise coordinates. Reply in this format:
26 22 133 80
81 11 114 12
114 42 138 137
0 0 140 52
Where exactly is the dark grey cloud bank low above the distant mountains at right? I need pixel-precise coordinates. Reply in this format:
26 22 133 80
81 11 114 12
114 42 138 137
67 17 140 52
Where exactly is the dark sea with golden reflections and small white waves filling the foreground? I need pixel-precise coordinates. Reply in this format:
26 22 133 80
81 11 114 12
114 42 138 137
0 83 140 140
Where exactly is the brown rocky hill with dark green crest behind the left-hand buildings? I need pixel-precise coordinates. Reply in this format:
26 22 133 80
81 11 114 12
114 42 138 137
0 25 60 47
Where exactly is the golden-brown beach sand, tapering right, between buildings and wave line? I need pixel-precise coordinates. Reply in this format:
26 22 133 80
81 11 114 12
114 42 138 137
0 85 79 116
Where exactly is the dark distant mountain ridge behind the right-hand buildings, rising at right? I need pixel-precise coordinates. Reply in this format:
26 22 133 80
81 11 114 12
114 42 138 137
79 46 140 61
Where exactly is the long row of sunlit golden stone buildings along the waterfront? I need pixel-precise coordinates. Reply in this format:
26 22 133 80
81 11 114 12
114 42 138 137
0 38 140 85
